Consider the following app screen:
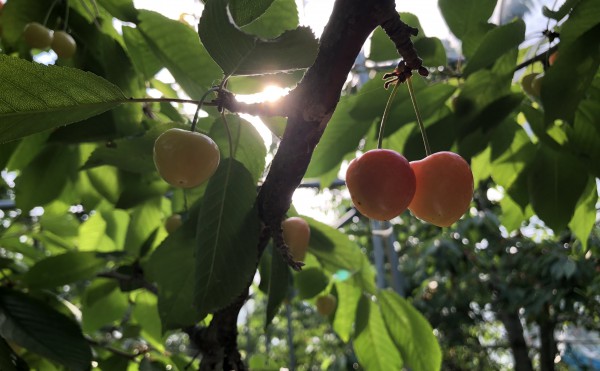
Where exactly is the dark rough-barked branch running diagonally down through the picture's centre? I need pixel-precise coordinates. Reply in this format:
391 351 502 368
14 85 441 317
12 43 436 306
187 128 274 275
195 0 426 370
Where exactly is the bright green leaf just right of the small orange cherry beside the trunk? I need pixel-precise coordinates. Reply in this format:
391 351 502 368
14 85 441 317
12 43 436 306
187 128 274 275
306 218 375 293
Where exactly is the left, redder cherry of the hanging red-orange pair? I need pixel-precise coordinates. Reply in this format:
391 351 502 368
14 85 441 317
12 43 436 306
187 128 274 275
346 149 415 220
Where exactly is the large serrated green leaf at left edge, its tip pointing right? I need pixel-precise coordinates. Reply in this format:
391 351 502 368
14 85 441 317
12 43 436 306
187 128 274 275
0 55 126 142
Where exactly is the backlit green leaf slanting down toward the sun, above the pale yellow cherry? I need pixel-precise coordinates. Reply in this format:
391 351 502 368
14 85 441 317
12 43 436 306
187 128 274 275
138 10 222 99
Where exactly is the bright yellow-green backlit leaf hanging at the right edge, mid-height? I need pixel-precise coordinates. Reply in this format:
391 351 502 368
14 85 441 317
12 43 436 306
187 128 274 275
569 177 598 250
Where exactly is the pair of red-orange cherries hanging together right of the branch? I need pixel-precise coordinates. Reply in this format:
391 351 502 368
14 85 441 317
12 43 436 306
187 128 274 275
346 149 473 227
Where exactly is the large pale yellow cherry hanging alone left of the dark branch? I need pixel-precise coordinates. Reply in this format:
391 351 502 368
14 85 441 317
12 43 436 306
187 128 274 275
154 128 221 188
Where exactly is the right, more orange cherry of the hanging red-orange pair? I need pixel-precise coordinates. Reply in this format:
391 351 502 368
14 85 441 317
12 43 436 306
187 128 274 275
408 152 473 227
